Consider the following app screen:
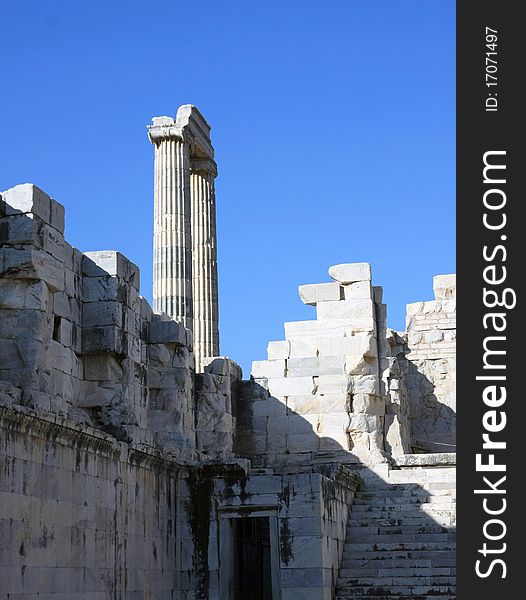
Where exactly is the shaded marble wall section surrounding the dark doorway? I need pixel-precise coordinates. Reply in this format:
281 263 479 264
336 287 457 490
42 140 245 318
175 466 360 600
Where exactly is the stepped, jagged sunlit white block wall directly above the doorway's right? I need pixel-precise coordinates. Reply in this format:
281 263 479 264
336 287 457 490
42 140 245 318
236 263 418 464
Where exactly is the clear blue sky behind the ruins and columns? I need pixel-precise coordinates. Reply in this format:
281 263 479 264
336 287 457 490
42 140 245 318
0 0 455 375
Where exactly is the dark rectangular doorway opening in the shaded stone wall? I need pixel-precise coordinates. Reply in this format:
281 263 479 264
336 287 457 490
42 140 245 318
232 517 272 600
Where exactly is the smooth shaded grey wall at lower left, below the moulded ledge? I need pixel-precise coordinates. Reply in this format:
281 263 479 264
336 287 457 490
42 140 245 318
0 407 180 600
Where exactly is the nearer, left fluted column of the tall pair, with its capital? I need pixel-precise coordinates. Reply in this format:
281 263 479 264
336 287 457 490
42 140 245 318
149 117 193 329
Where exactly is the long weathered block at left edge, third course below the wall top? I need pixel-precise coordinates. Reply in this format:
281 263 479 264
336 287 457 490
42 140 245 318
0 248 64 291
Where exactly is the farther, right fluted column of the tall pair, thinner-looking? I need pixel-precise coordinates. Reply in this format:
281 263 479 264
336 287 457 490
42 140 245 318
190 158 219 372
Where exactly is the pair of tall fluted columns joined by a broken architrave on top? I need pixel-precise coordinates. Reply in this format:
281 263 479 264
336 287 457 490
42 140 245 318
149 104 219 372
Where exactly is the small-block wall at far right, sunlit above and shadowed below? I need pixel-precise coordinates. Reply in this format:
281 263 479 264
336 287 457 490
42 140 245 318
402 275 456 452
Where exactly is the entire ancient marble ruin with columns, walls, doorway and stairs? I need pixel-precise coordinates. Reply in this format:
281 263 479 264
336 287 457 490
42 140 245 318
0 105 456 600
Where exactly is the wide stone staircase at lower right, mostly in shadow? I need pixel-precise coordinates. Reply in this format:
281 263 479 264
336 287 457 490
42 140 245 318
335 469 456 600
